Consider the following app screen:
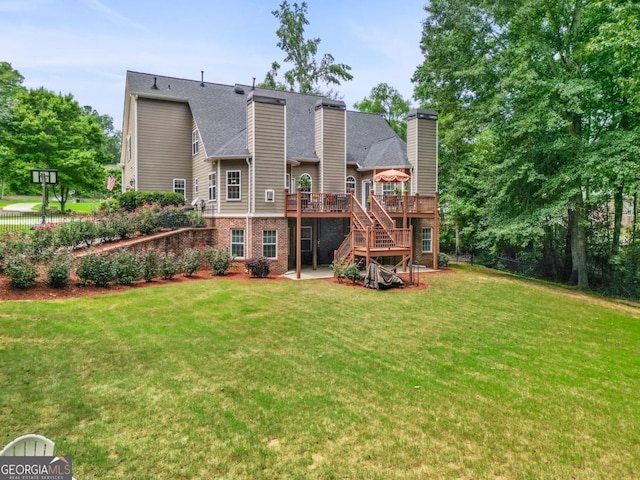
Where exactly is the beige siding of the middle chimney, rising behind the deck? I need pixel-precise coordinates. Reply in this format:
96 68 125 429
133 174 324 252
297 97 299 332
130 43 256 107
316 108 346 193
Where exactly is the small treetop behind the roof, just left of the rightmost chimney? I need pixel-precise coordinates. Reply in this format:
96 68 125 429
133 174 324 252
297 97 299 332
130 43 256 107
353 83 410 140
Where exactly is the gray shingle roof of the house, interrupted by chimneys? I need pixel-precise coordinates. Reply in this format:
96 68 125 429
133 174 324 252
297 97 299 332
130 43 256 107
127 71 409 168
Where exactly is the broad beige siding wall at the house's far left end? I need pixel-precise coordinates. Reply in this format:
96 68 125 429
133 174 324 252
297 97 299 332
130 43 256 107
136 98 193 202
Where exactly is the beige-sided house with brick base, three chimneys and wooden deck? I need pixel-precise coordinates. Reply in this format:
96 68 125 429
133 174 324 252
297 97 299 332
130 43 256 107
121 72 438 280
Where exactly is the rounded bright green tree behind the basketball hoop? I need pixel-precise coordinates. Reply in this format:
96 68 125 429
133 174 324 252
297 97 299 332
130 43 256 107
6 88 107 211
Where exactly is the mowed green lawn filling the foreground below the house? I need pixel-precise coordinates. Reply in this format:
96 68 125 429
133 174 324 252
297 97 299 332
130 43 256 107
0 267 640 479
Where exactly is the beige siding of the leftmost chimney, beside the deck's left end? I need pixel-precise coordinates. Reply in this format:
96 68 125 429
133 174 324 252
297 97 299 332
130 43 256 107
248 102 286 215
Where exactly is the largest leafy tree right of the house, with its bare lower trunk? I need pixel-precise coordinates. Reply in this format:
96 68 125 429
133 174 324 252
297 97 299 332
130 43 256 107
414 0 640 287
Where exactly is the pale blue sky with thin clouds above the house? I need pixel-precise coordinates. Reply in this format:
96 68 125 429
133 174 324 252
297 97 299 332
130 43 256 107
0 0 426 129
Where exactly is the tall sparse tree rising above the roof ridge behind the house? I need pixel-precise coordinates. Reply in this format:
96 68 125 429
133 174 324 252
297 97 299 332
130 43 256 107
260 0 353 94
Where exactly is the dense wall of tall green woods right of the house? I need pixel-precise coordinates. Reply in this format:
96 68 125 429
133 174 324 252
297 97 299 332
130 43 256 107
413 0 640 296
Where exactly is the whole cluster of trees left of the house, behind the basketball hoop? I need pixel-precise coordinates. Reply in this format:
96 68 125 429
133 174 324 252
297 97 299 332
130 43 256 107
0 61 121 212
